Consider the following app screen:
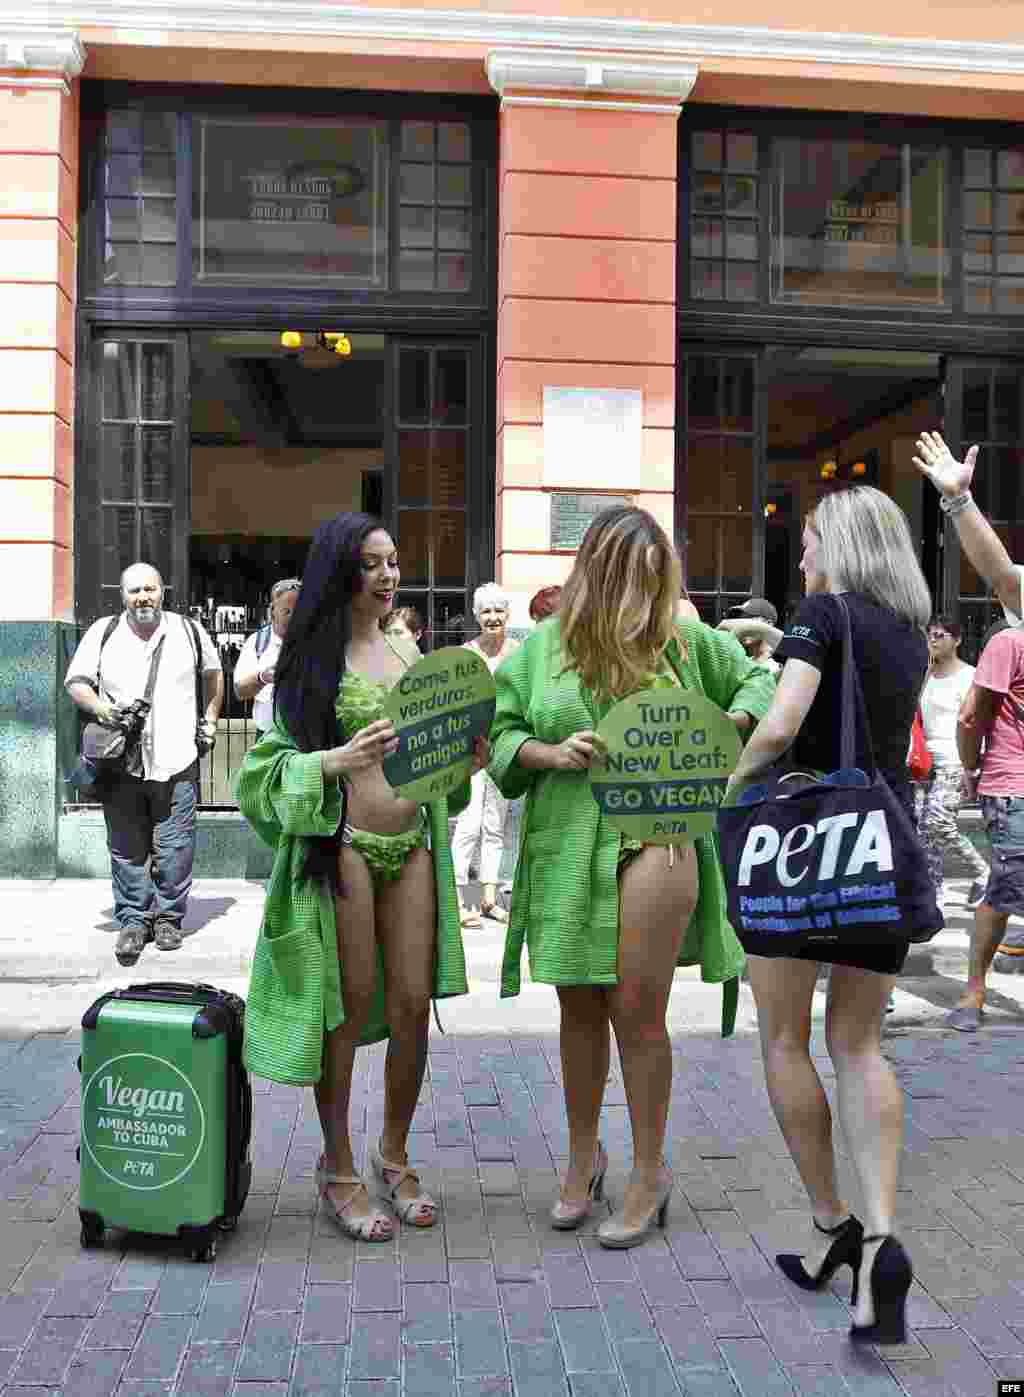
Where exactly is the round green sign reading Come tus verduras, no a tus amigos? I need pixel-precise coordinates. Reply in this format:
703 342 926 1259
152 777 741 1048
384 645 495 800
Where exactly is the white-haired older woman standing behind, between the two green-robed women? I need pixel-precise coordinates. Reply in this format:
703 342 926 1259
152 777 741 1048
451 583 517 926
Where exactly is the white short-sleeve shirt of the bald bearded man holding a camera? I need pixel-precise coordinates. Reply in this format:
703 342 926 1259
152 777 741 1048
64 612 221 781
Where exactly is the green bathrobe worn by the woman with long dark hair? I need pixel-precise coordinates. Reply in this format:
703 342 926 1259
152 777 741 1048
235 724 469 1085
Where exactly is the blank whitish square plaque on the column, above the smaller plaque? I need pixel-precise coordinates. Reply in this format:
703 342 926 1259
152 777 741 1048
543 387 644 490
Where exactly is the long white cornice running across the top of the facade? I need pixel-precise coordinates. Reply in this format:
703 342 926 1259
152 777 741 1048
0 0 1024 75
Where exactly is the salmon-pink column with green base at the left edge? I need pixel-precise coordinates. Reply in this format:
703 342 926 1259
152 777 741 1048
0 32 84 877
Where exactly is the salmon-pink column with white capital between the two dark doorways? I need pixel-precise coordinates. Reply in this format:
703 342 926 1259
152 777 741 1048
488 52 696 590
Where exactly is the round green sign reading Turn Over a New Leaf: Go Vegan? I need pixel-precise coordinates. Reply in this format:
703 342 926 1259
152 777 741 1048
590 689 742 844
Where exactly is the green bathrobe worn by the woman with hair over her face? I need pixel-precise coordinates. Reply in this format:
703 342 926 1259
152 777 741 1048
489 617 775 1034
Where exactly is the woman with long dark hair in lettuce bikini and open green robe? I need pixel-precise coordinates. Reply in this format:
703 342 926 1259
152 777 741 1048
237 514 486 1242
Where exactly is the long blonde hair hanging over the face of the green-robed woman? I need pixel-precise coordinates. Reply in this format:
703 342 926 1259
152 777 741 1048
559 504 682 699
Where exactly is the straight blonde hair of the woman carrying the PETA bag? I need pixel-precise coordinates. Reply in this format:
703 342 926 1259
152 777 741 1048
807 485 932 630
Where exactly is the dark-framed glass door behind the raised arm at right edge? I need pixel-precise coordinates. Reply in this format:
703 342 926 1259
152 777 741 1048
942 358 1024 661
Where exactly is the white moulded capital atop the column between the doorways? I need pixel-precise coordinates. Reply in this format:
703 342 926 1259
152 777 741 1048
488 49 697 105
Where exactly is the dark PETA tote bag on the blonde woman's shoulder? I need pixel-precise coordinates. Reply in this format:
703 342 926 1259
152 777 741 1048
718 598 943 960
